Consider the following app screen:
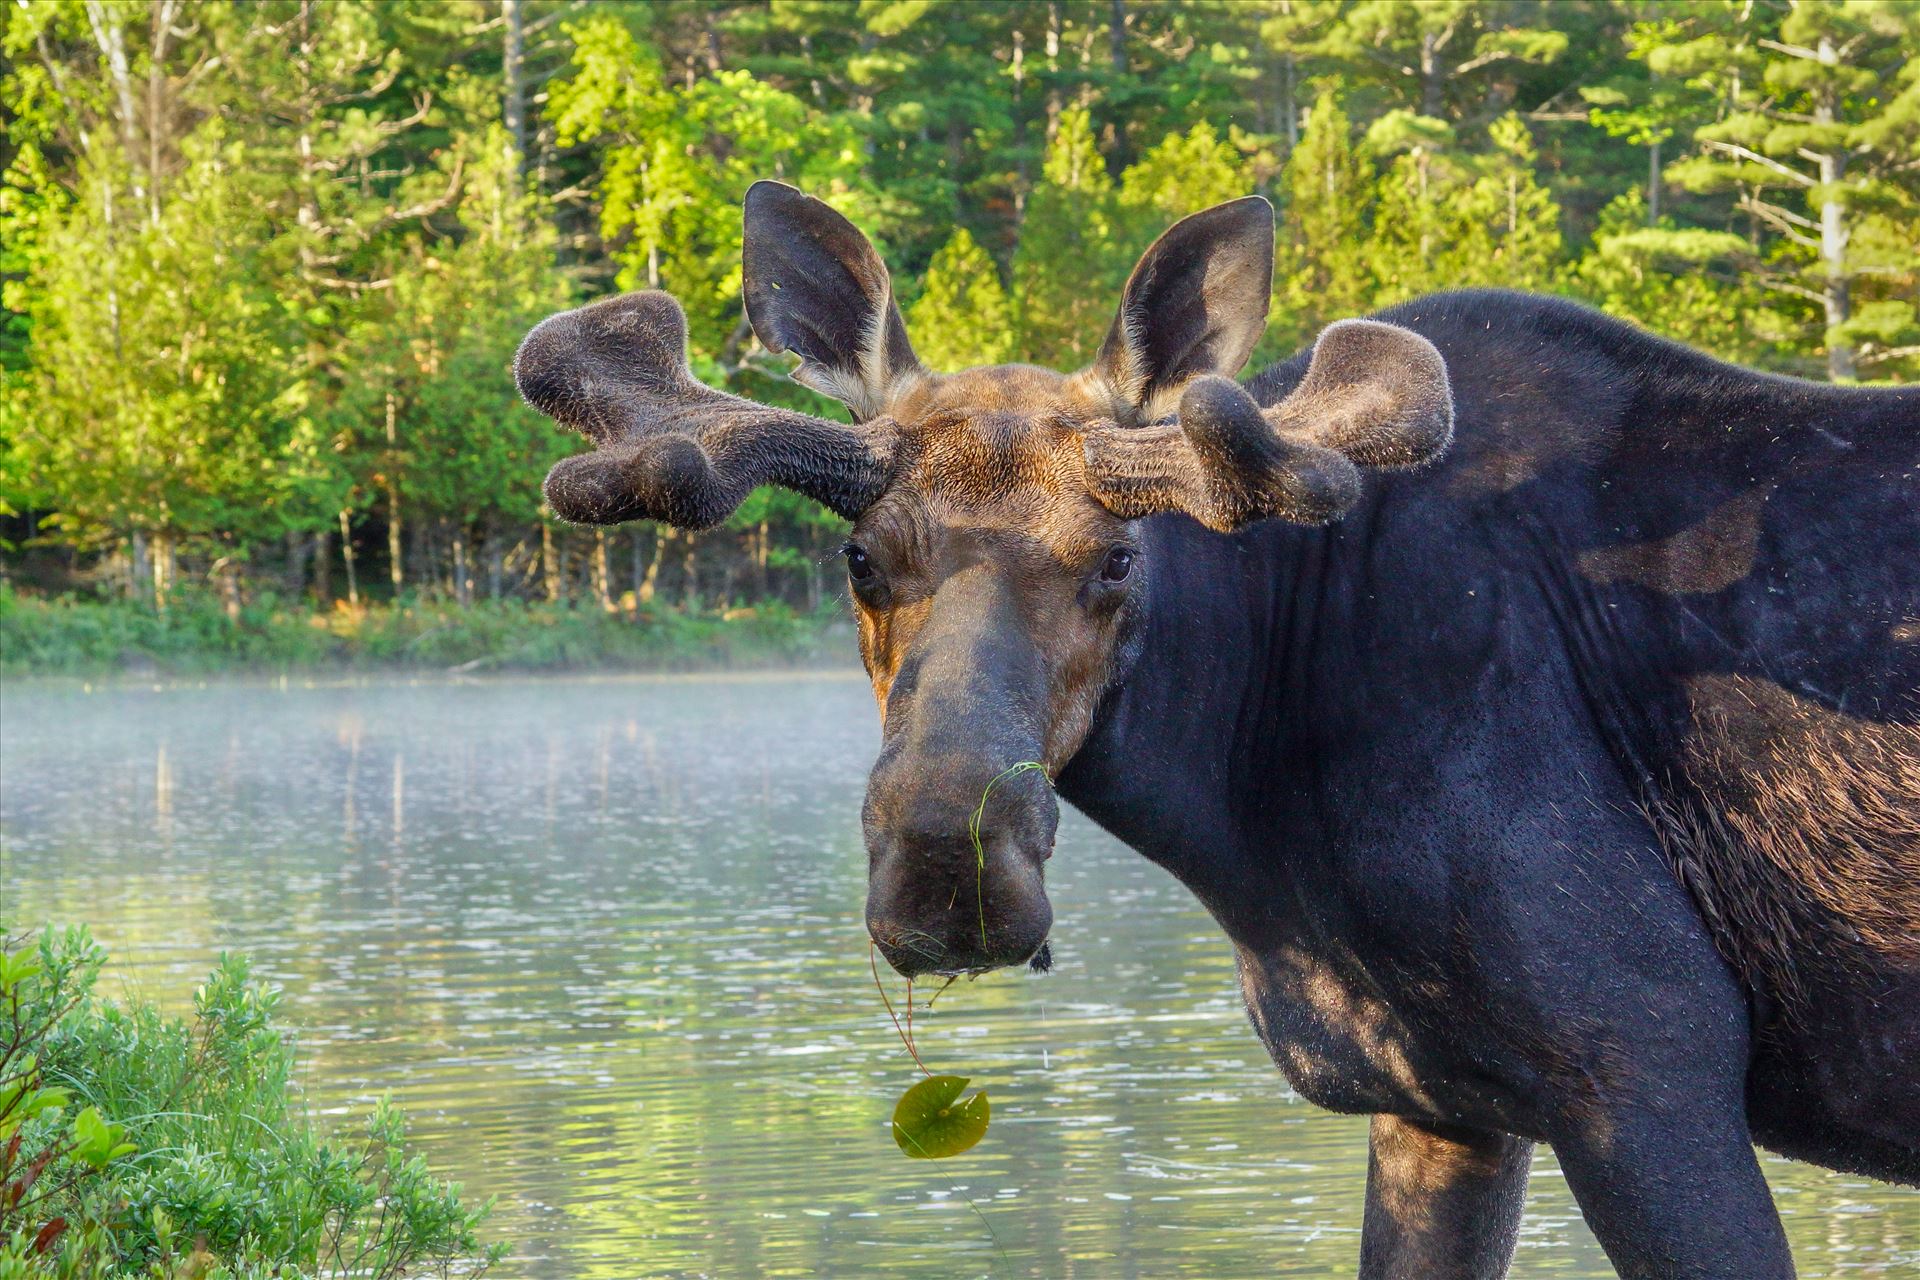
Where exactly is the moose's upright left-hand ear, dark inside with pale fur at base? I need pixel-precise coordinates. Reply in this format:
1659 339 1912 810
741 182 925 420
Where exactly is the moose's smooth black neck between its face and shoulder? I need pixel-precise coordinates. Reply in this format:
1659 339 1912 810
1058 516 1363 940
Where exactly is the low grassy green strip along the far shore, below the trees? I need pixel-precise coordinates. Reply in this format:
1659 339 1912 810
0 585 852 679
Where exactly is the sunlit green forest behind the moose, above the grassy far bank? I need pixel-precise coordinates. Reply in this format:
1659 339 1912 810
0 0 1920 656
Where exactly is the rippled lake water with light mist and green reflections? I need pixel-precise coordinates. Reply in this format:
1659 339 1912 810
0 676 1920 1280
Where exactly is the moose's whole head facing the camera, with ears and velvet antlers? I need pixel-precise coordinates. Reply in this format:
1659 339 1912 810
515 182 1452 977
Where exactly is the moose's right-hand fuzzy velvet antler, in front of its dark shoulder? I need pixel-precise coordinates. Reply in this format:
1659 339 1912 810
1083 320 1453 533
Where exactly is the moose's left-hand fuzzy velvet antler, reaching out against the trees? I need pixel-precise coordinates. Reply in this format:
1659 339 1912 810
513 292 893 530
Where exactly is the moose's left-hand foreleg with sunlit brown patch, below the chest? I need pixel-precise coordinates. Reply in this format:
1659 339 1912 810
1359 1115 1534 1280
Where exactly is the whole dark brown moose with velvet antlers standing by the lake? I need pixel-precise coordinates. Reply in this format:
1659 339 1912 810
515 182 1920 1280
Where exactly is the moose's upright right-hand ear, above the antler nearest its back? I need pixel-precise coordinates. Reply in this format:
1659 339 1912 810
1089 196 1273 422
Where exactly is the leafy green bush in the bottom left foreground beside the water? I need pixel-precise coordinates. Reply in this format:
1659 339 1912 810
0 929 503 1280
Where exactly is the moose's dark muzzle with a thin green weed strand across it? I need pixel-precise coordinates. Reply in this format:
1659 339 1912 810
862 762 1060 977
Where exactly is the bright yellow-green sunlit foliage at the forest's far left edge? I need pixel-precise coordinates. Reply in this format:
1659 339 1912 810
4 119 313 552
